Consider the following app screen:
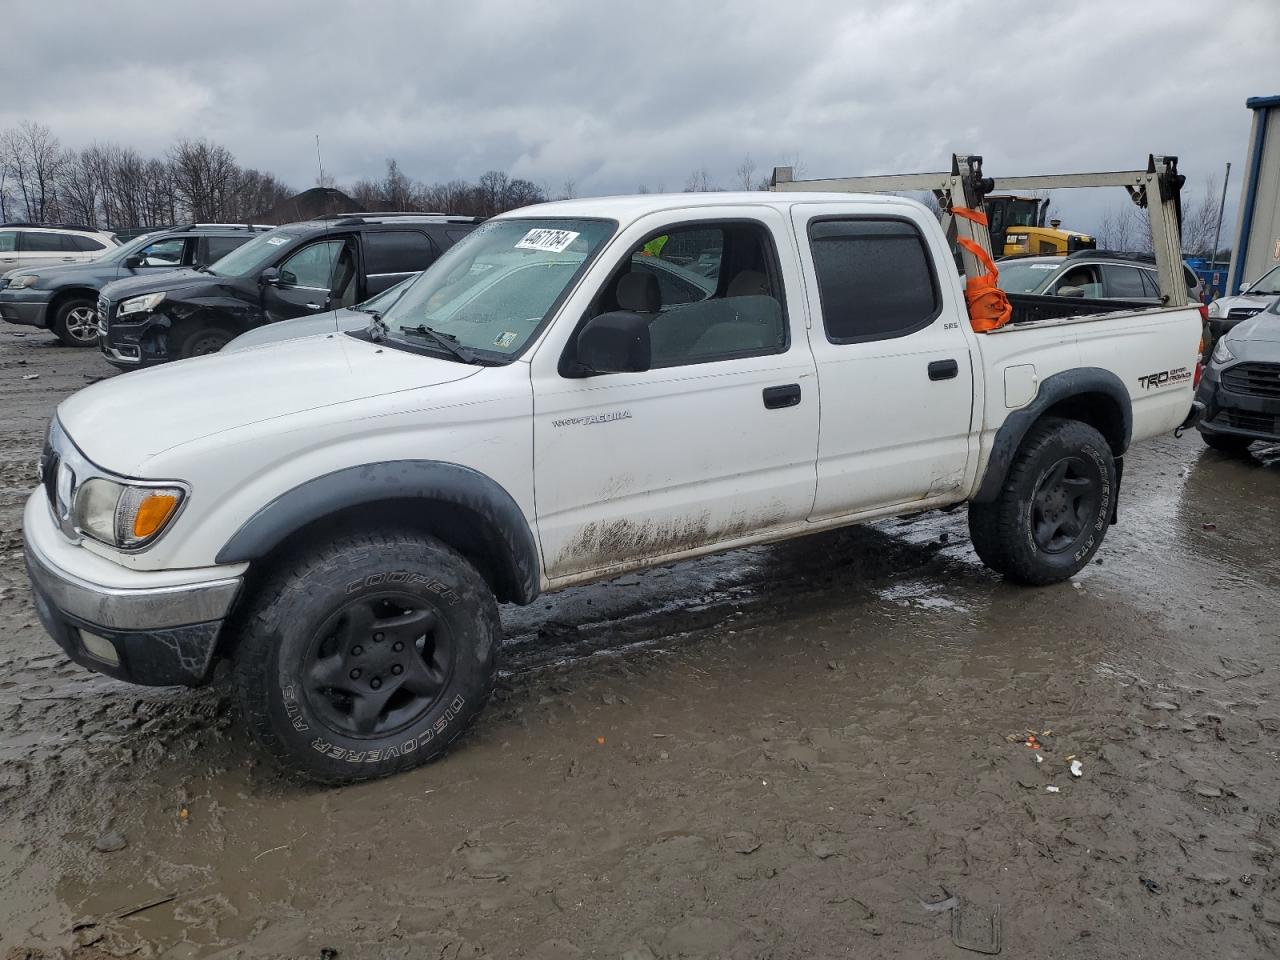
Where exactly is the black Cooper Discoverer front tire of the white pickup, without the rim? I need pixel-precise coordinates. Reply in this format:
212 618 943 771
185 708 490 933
234 532 502 783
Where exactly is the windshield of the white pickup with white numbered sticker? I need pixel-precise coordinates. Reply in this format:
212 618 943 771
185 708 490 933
383 219 617 360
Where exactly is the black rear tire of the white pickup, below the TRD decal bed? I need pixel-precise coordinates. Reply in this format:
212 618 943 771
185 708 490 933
969 417 1116 586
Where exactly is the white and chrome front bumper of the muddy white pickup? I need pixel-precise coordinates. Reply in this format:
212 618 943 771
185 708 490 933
23 489 243 686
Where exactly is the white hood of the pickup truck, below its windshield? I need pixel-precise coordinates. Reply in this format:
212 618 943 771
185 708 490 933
58 334 480 476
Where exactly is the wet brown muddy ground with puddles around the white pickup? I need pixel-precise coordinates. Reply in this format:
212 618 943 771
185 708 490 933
0 328 1280 960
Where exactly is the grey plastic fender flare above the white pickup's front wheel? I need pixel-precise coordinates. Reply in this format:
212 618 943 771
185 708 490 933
216 460 540 603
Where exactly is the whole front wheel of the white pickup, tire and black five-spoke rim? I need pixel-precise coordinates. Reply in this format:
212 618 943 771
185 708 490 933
236 534 502 783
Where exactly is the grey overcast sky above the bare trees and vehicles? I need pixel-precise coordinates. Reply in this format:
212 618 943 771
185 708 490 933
0 0 1280 229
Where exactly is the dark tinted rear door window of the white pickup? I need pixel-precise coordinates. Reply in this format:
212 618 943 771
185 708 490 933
809 218 942 343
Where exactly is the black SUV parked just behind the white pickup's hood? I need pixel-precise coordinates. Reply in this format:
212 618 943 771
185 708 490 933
97 214 479 370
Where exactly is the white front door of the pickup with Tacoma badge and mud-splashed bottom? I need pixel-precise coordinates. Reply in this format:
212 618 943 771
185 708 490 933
532 207 818 581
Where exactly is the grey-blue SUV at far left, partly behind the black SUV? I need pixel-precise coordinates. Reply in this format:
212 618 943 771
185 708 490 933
0 223 271 347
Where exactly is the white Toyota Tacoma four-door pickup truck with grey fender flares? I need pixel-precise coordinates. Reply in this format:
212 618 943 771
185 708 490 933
24 193 1201 782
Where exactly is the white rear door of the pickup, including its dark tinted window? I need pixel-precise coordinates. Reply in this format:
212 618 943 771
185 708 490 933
792 204 973 520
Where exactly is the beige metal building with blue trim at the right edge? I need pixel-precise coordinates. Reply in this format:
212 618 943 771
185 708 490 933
1228 96 1280 293
